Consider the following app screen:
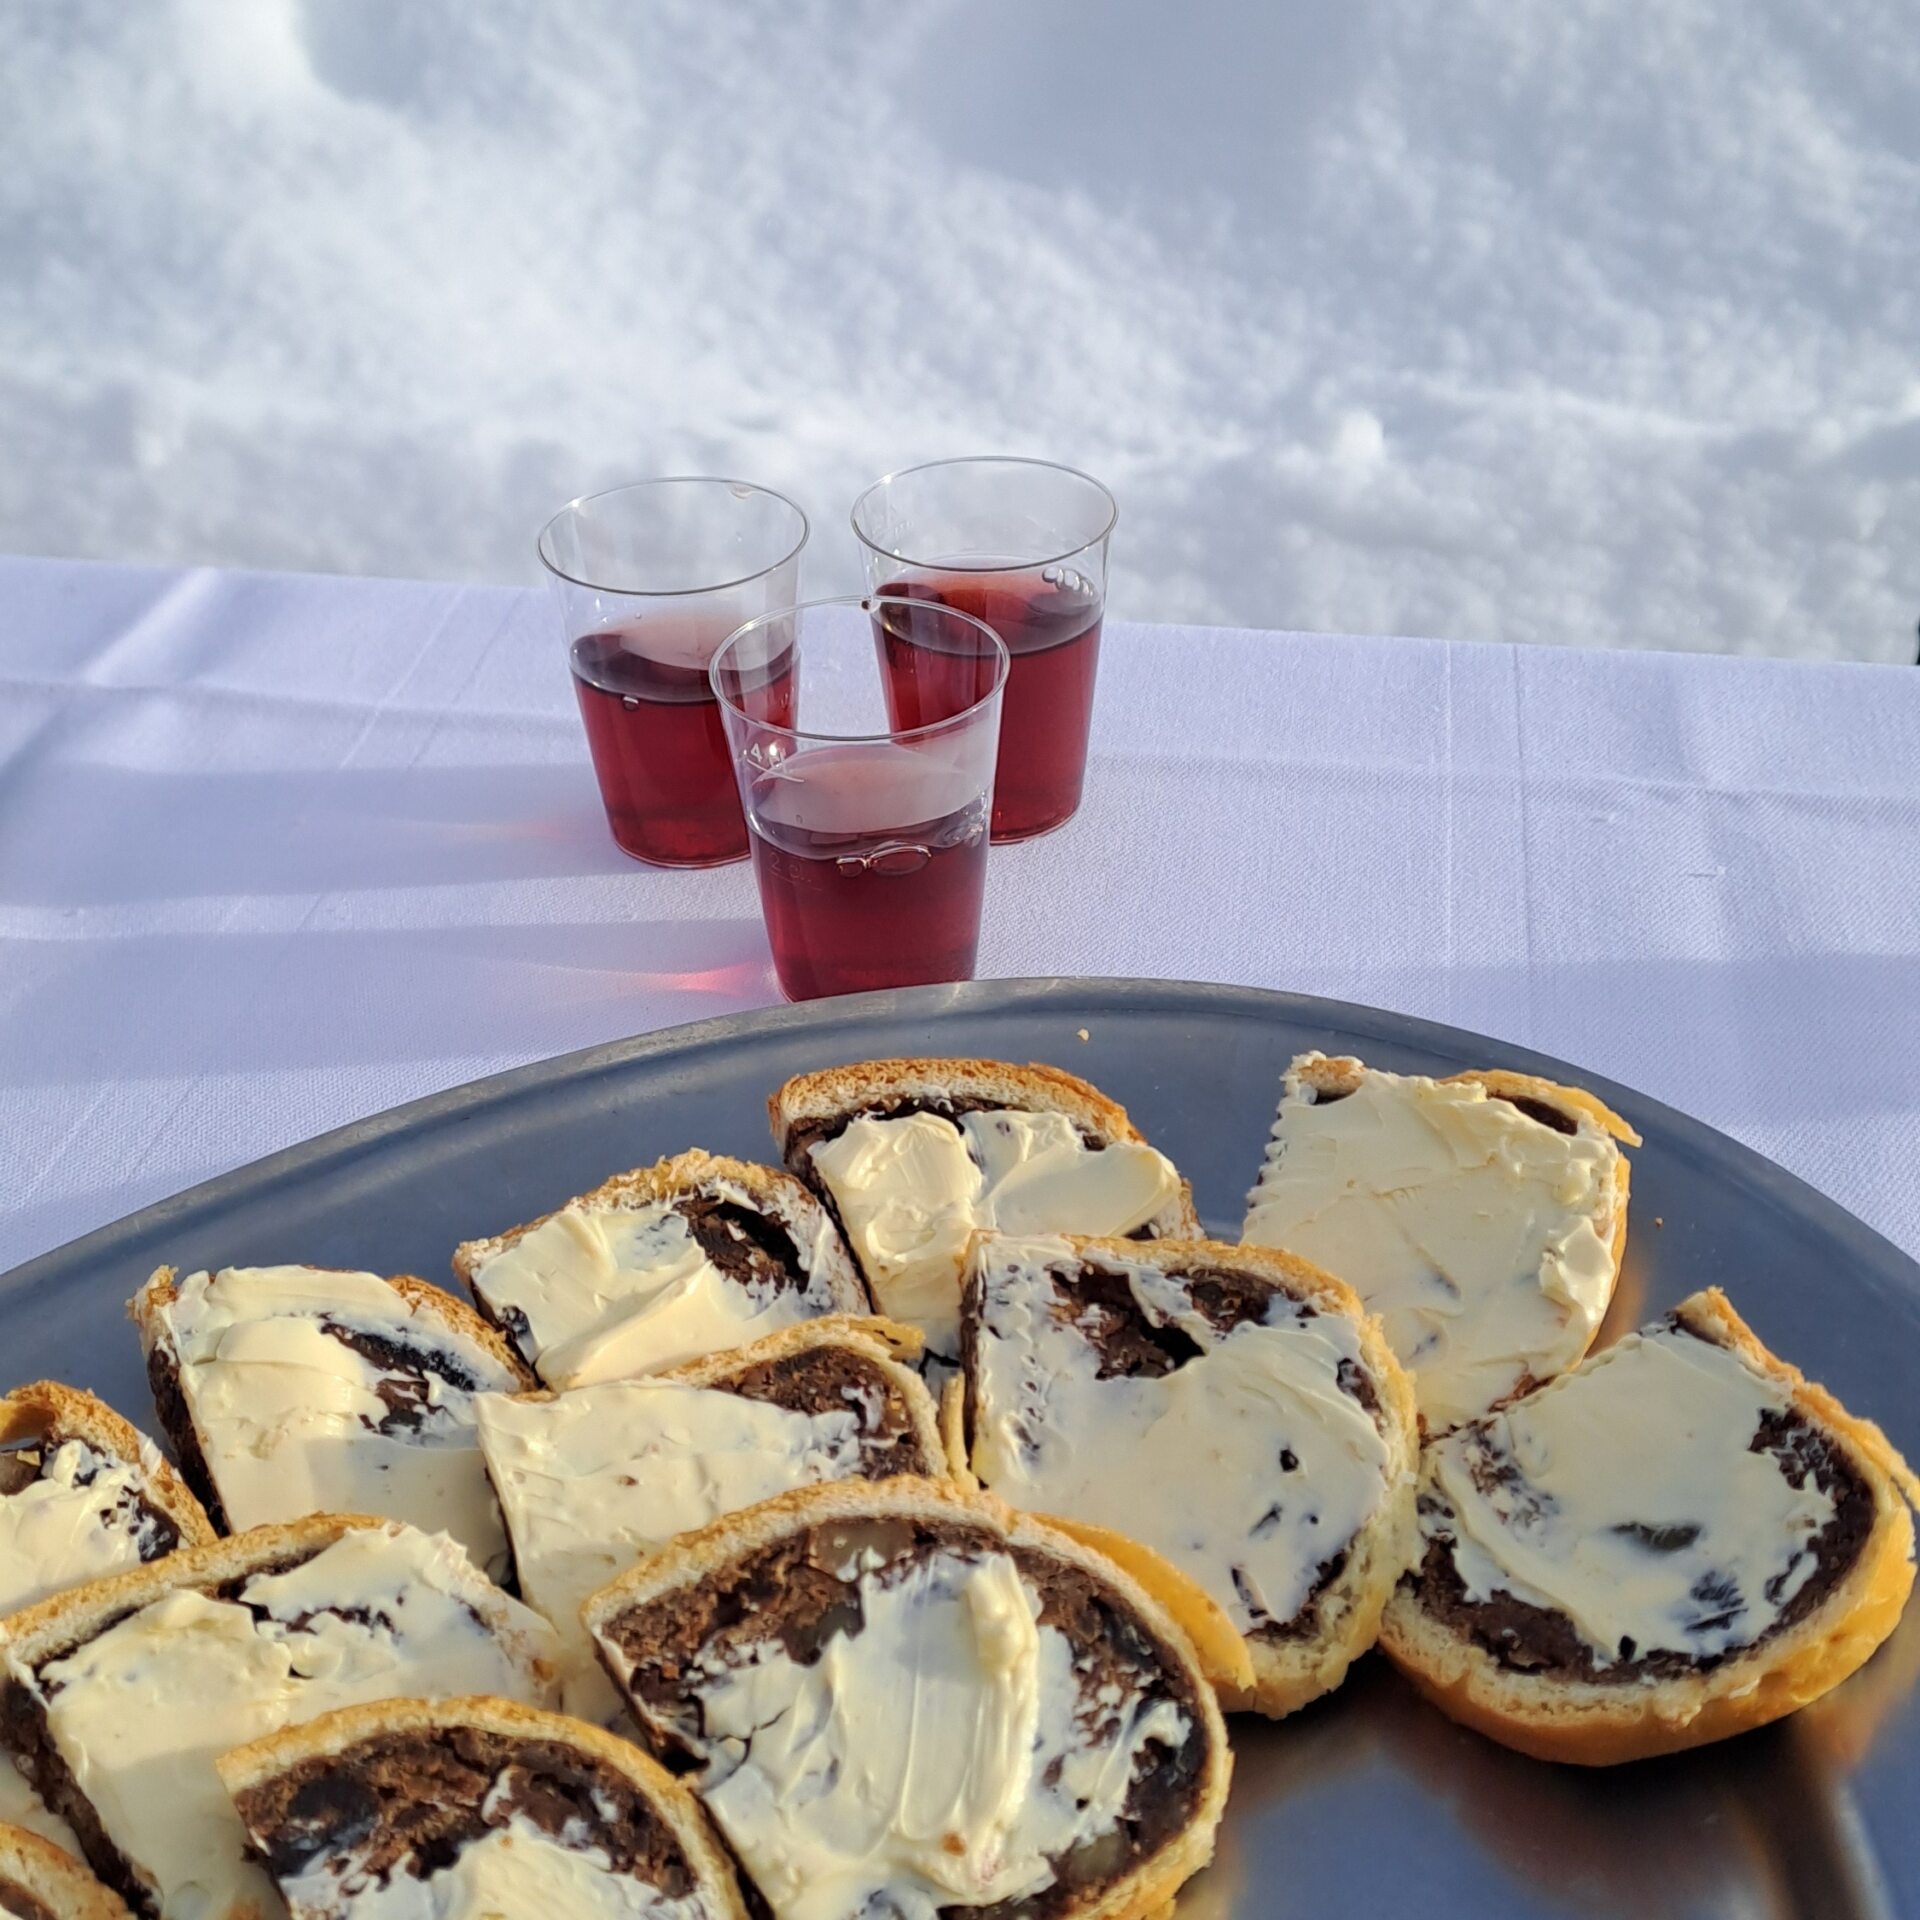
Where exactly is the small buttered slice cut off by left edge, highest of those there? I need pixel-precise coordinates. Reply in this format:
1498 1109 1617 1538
0 1380 213 1620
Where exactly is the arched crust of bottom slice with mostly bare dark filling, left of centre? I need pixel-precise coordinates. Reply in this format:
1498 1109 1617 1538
213 1695 747 1920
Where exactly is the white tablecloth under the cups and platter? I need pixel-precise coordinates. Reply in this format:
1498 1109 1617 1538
0 561 1920 1267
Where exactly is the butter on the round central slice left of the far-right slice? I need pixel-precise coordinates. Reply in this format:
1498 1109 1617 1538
972 1238 1392 1634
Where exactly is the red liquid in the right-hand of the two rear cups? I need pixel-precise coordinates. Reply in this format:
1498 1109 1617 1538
876 568 1102 841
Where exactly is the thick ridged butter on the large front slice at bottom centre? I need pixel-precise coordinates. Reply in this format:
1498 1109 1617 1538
695 1549 1190 1920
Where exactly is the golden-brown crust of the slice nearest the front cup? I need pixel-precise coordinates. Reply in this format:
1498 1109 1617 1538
766 1060 1200 1240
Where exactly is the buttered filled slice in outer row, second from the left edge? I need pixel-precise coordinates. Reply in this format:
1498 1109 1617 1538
131 1267 534 1578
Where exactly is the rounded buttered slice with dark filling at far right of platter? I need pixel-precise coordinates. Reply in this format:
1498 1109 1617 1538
1382 1290 1916 1763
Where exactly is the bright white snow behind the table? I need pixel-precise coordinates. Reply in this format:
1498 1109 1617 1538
0 0 1920 660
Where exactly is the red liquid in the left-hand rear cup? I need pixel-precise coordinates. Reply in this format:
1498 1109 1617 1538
572 622 793 866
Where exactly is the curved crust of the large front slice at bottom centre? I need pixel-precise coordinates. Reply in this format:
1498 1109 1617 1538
582 1466 1233 1920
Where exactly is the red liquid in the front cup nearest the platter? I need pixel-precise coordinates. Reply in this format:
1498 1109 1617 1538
753 747 987 1000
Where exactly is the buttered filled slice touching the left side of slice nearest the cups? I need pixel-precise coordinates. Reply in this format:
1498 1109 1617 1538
453 1150 872 1386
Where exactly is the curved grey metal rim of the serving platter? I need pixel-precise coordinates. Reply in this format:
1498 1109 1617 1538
0 973 1920 1302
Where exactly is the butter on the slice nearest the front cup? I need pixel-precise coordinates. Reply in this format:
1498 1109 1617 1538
812 1108 1181 1359
